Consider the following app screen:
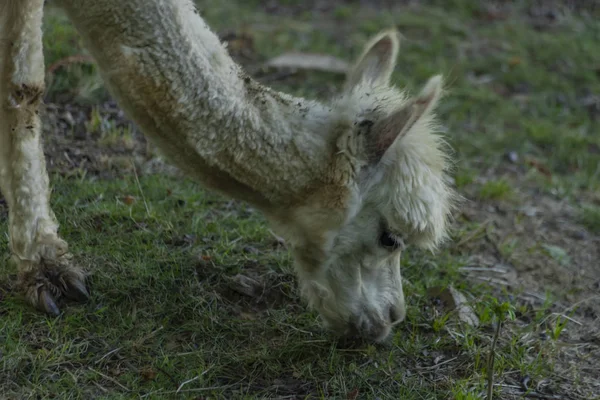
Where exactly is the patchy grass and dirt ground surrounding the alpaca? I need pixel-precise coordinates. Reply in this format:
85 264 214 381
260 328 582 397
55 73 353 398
0 0 600 400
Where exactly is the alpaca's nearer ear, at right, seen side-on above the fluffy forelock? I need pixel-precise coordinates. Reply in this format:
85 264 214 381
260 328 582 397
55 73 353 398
369 75 443 163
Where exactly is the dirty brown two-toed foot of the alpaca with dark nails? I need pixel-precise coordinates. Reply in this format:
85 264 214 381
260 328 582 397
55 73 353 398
19 254 89 316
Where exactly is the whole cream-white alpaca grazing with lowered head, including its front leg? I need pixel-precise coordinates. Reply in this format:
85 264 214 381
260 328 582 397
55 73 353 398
0 0 455 341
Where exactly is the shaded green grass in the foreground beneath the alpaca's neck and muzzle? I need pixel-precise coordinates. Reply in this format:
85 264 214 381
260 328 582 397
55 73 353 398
0 176 560 398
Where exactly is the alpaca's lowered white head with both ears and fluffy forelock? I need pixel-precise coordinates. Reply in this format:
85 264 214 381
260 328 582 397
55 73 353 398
268 31 455 341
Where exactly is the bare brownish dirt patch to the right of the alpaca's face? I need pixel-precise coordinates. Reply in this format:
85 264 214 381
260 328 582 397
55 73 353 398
456 166 600 398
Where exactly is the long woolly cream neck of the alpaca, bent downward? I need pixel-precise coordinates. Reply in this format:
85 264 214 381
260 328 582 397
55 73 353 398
60 0 331 208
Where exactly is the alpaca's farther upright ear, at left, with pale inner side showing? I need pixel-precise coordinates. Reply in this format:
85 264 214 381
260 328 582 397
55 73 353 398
345 29 400 90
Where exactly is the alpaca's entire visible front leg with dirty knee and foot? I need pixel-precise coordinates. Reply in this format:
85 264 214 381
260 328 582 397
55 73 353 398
0 0 87 314
